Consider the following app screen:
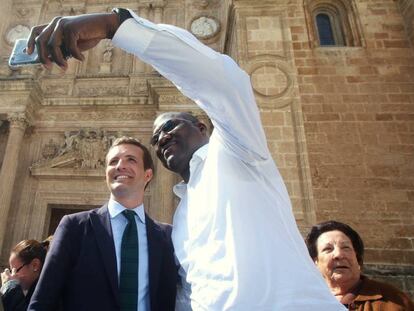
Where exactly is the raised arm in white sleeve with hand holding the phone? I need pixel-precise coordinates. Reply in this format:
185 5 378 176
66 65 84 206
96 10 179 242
28 11 270 163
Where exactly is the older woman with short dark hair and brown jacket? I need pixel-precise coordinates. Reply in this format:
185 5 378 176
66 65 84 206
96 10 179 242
306 221 414 311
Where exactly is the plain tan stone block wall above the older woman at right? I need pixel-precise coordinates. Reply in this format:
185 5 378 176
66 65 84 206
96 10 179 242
291 0 414 290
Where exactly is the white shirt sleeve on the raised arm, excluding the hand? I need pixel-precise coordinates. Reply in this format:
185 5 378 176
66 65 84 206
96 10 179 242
113 12 270 163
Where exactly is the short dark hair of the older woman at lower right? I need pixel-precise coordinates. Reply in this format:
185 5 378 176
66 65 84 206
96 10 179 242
305 220 364 267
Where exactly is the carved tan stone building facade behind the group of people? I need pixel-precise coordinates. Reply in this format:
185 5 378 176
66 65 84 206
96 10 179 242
0 0 414 294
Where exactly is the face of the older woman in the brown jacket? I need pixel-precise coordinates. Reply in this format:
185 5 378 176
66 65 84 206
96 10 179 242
315 230 361 288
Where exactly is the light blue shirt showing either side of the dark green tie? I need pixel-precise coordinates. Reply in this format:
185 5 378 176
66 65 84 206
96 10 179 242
108 199 150 311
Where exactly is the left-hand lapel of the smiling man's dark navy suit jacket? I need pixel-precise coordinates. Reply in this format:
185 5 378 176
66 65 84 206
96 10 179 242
90 204 119 303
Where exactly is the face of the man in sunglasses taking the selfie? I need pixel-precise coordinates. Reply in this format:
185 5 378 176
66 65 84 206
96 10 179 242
151 113 208 182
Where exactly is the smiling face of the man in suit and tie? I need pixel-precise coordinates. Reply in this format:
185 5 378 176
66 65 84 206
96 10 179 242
105 144 152 208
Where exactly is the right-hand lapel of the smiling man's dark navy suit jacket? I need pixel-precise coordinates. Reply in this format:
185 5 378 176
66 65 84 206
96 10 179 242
145 214 164 301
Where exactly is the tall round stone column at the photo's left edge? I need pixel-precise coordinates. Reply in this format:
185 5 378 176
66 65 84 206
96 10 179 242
0 113 28 251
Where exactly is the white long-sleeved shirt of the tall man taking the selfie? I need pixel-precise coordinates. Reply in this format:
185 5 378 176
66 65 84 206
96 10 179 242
113 12 345 311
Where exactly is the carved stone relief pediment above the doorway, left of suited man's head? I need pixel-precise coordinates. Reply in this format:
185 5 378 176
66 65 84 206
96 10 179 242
30 129 115 177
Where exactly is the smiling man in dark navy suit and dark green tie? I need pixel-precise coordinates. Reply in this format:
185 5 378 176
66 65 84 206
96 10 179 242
28 137 177 311
